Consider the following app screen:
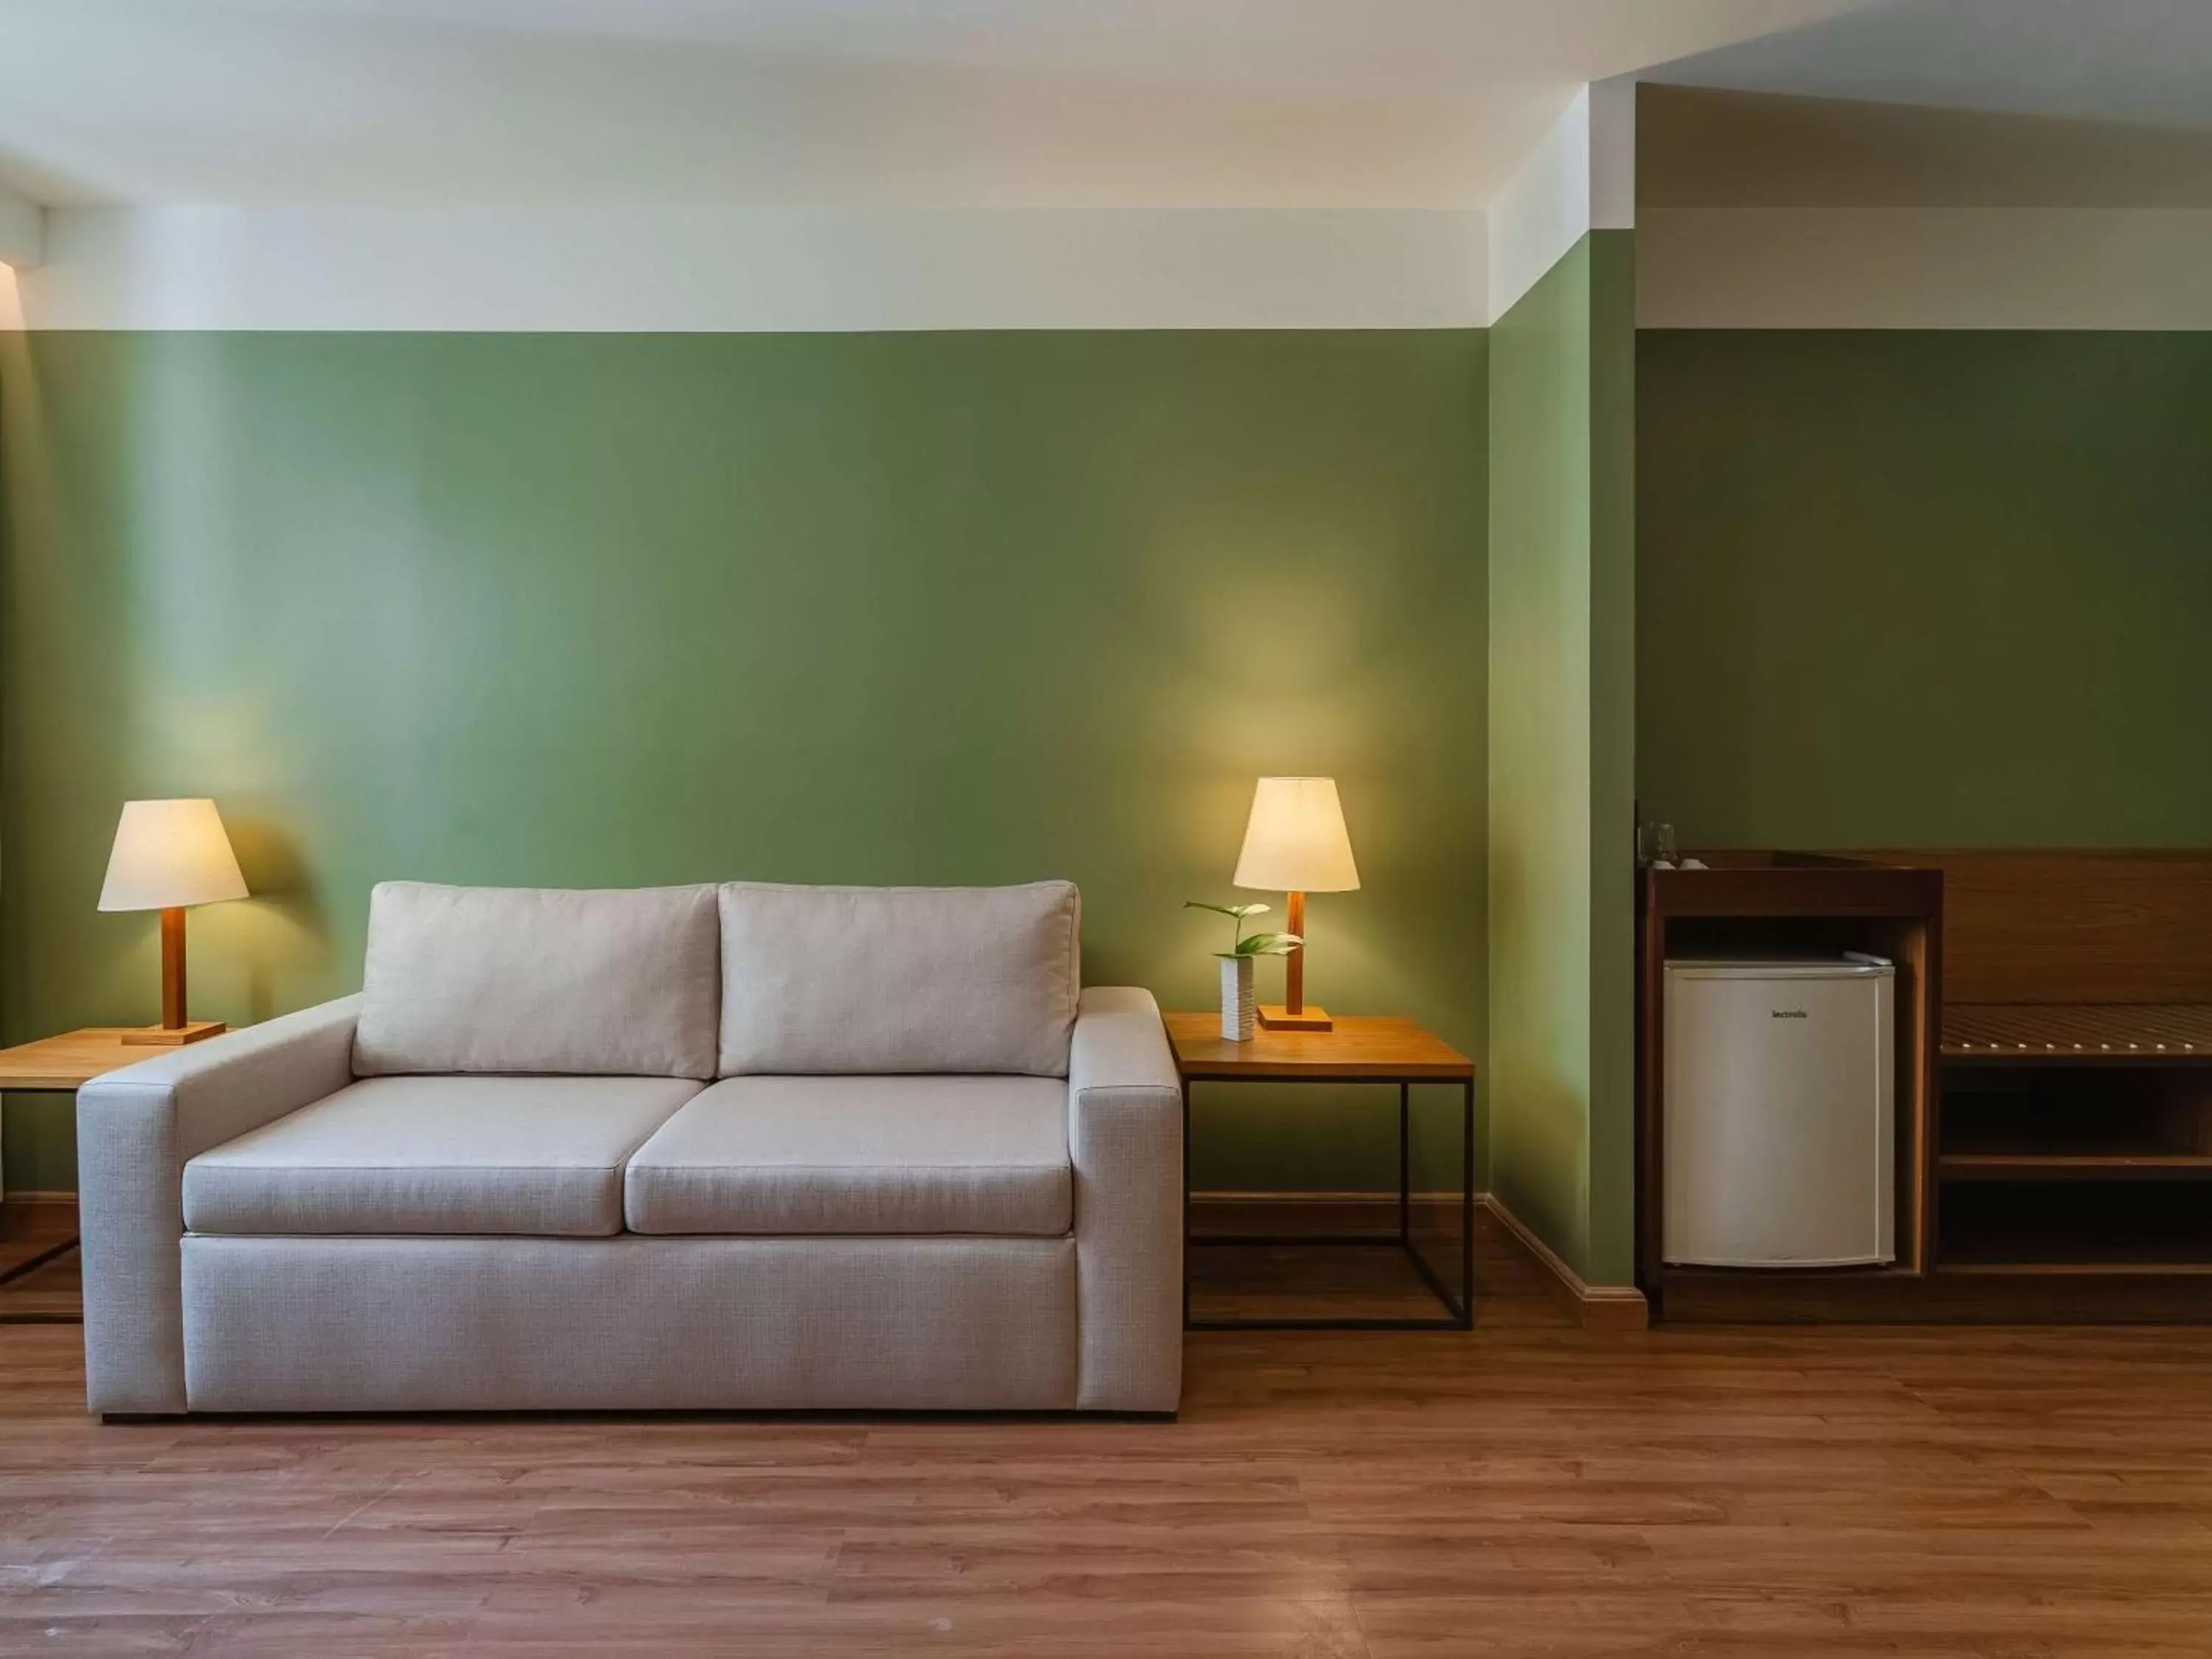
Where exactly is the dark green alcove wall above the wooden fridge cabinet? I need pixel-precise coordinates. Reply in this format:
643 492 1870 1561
1637 330 2212 847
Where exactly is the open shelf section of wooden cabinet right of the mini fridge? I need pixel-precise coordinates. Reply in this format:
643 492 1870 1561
1891 852 2212 1283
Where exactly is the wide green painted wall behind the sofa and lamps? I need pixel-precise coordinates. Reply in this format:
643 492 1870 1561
0 332 1486 1188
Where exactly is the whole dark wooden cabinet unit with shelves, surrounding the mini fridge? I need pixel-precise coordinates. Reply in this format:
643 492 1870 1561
1639 849 2212 1321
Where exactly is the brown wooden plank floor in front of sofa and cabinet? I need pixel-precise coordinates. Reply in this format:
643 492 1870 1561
0 1241 2212 1659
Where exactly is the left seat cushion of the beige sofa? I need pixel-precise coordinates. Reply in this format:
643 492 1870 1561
184 1077 699 1237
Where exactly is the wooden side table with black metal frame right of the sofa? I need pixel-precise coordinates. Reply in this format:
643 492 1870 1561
1166 1013 1475 1332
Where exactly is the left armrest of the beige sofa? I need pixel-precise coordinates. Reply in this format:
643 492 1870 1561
77 995 361 1411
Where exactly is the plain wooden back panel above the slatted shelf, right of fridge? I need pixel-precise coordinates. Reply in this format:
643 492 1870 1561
1865 847 2212 1002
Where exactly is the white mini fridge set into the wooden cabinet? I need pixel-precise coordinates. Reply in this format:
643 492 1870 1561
1661 958 1898 1267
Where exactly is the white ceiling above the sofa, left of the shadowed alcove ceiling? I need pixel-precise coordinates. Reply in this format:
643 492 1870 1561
0 0 1876 208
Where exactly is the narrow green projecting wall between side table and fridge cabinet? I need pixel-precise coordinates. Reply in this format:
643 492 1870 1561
1489 230 1637 1283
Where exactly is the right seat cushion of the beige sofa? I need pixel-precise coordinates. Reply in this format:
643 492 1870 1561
624 1077 1073 1237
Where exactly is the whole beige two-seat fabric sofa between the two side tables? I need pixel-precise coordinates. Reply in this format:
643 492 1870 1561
77 883 1183 1413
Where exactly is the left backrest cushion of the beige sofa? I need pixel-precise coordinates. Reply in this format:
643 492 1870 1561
354 880 721 1077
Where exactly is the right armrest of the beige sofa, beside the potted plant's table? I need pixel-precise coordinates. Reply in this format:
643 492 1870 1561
1068 987 1183 1411
